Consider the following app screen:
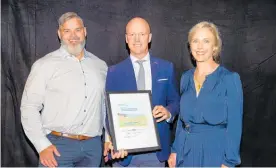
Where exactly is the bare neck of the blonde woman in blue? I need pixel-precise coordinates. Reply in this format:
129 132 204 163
196 61 219 76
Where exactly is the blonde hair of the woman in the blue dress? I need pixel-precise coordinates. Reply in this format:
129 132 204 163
188 21 222 63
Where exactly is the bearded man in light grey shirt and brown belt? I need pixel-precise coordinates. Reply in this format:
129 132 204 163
21 12 108 167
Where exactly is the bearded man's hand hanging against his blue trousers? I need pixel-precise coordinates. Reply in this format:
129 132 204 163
39 145 60 167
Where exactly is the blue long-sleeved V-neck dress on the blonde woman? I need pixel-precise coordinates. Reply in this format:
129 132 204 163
172 66 243 167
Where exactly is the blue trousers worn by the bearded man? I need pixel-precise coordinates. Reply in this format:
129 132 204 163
39 134 102 167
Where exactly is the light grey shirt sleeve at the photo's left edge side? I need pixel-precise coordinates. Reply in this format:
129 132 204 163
20 60 51 153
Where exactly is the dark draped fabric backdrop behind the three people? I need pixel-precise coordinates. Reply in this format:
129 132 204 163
1 0 276 166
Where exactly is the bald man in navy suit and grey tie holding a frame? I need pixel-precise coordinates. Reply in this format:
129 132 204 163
106 17 179 167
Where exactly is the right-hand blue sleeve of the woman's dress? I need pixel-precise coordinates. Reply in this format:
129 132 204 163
222 73 243 167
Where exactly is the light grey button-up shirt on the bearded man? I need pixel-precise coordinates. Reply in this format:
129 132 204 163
21 47 107 152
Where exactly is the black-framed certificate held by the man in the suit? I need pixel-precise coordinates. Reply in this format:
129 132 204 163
106 91 161 153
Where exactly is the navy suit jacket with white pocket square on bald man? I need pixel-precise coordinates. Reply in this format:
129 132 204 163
106 56 179 166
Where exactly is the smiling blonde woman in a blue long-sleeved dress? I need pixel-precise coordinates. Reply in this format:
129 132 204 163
168 22 243 167
